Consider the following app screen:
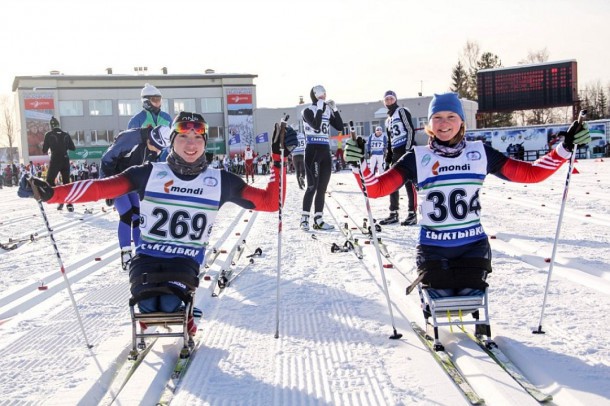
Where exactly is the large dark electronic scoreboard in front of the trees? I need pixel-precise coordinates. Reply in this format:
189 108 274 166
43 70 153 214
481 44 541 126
477 60 578 113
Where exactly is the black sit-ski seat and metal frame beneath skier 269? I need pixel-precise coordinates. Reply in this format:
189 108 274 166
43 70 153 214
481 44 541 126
129 272 199 359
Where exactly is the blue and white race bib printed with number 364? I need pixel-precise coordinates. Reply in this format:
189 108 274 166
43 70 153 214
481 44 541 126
413 141 487 247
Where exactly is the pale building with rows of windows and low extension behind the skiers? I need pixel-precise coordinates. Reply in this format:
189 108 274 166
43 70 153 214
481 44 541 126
13 68 477 163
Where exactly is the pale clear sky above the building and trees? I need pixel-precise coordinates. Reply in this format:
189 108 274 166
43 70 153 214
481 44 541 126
0 0 610 107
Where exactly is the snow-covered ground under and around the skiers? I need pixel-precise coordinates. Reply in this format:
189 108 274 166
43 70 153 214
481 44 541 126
0 160 610 406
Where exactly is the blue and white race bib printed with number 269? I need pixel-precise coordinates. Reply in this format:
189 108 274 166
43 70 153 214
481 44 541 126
136 162 221 264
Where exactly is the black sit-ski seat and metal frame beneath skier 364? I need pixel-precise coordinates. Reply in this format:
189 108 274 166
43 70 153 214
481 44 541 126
407 258 491 351
